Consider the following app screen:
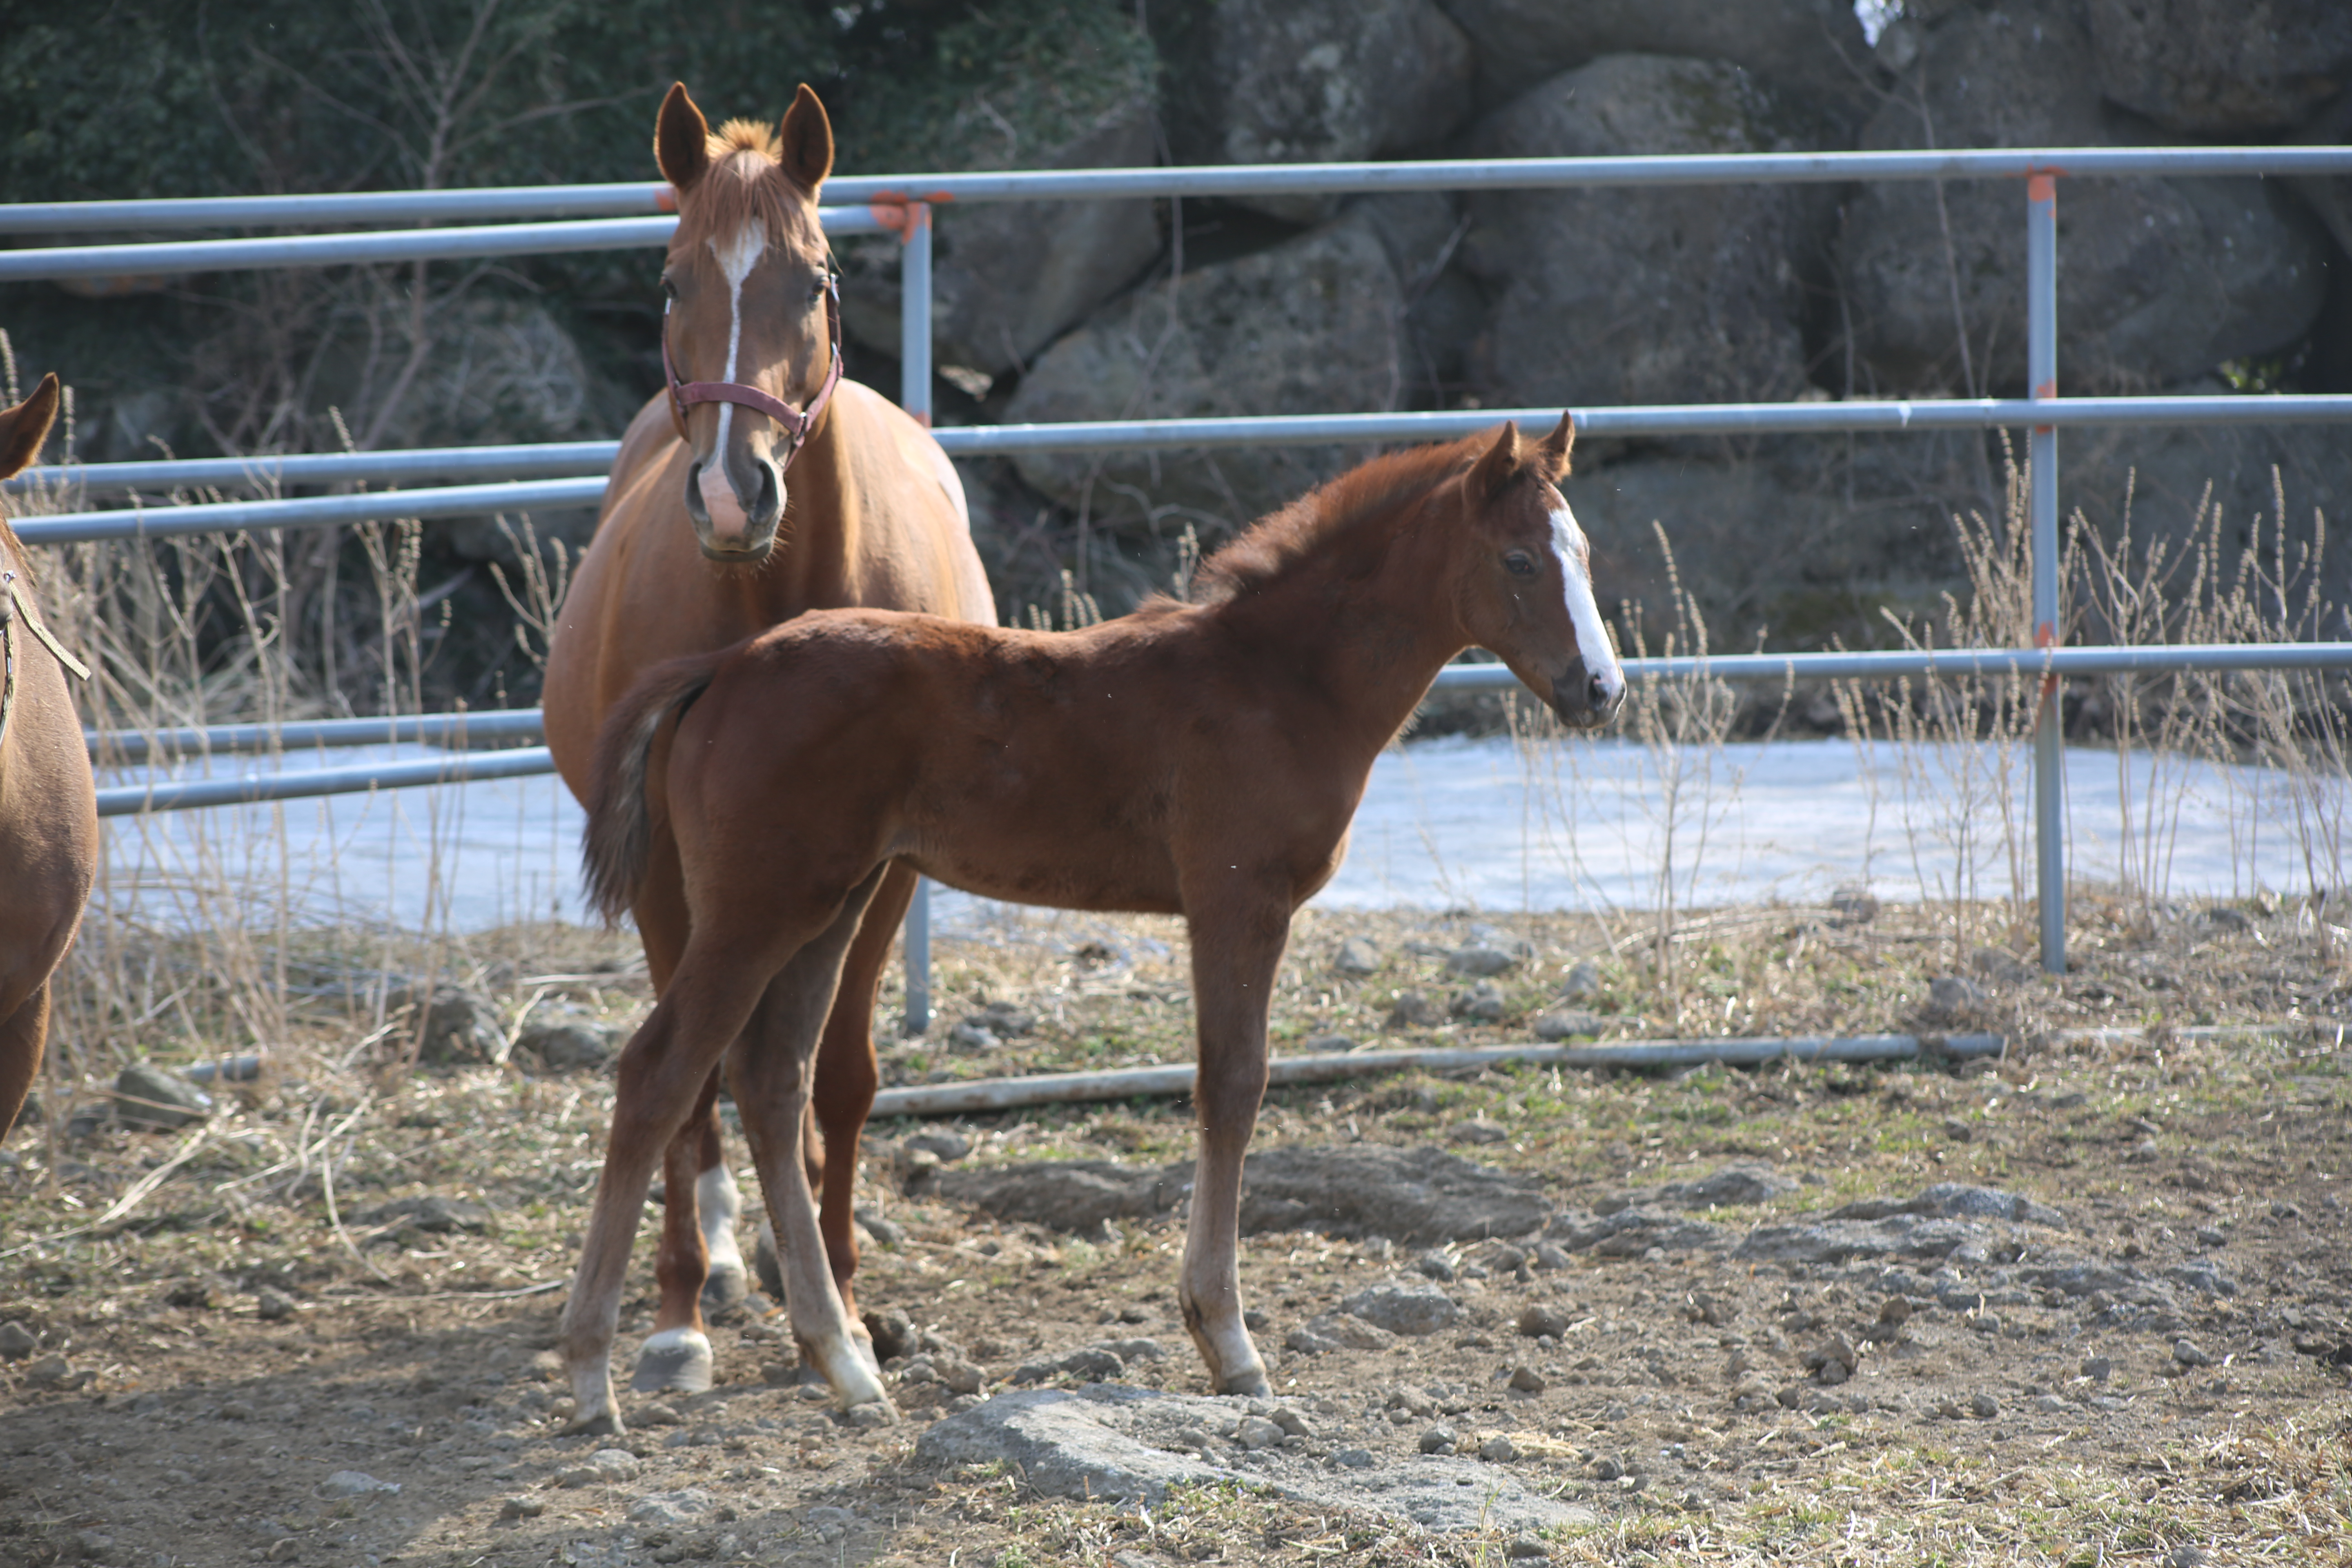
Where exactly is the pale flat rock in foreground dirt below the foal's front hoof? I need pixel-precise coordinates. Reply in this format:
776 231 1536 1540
915 1382 1592 1530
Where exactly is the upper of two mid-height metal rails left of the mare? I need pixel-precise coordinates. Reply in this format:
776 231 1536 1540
0 442 621 496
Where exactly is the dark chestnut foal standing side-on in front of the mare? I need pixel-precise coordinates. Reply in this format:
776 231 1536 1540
562 419 1625 1429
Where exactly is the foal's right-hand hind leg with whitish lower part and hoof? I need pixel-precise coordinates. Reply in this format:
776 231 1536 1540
729 867 889 1408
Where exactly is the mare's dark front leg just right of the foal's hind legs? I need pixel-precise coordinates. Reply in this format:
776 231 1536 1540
809 865 915 1335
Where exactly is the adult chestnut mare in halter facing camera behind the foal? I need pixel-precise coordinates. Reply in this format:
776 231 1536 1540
543 85 995 1389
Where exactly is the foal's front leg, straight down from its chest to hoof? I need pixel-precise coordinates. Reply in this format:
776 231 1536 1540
1176 898 1291 1396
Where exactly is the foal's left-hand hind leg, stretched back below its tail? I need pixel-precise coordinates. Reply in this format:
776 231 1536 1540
562 919 814 1432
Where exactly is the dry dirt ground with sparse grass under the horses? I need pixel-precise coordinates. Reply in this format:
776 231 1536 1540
0 898 2352 1568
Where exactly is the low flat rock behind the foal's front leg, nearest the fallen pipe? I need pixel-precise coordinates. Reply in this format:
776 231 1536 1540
936 1145 1552 1246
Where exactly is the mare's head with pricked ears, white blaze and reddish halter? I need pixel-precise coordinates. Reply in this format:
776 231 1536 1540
654 85 837 564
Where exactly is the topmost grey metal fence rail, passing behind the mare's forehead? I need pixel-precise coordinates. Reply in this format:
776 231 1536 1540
18 148 2352 235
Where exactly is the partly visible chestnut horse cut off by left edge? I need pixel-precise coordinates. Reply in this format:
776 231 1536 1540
0 376 99 1138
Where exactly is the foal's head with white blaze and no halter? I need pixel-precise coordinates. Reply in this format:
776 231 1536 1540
1456 414 1625 729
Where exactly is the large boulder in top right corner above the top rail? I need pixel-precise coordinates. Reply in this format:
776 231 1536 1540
2084 0 2352 136
